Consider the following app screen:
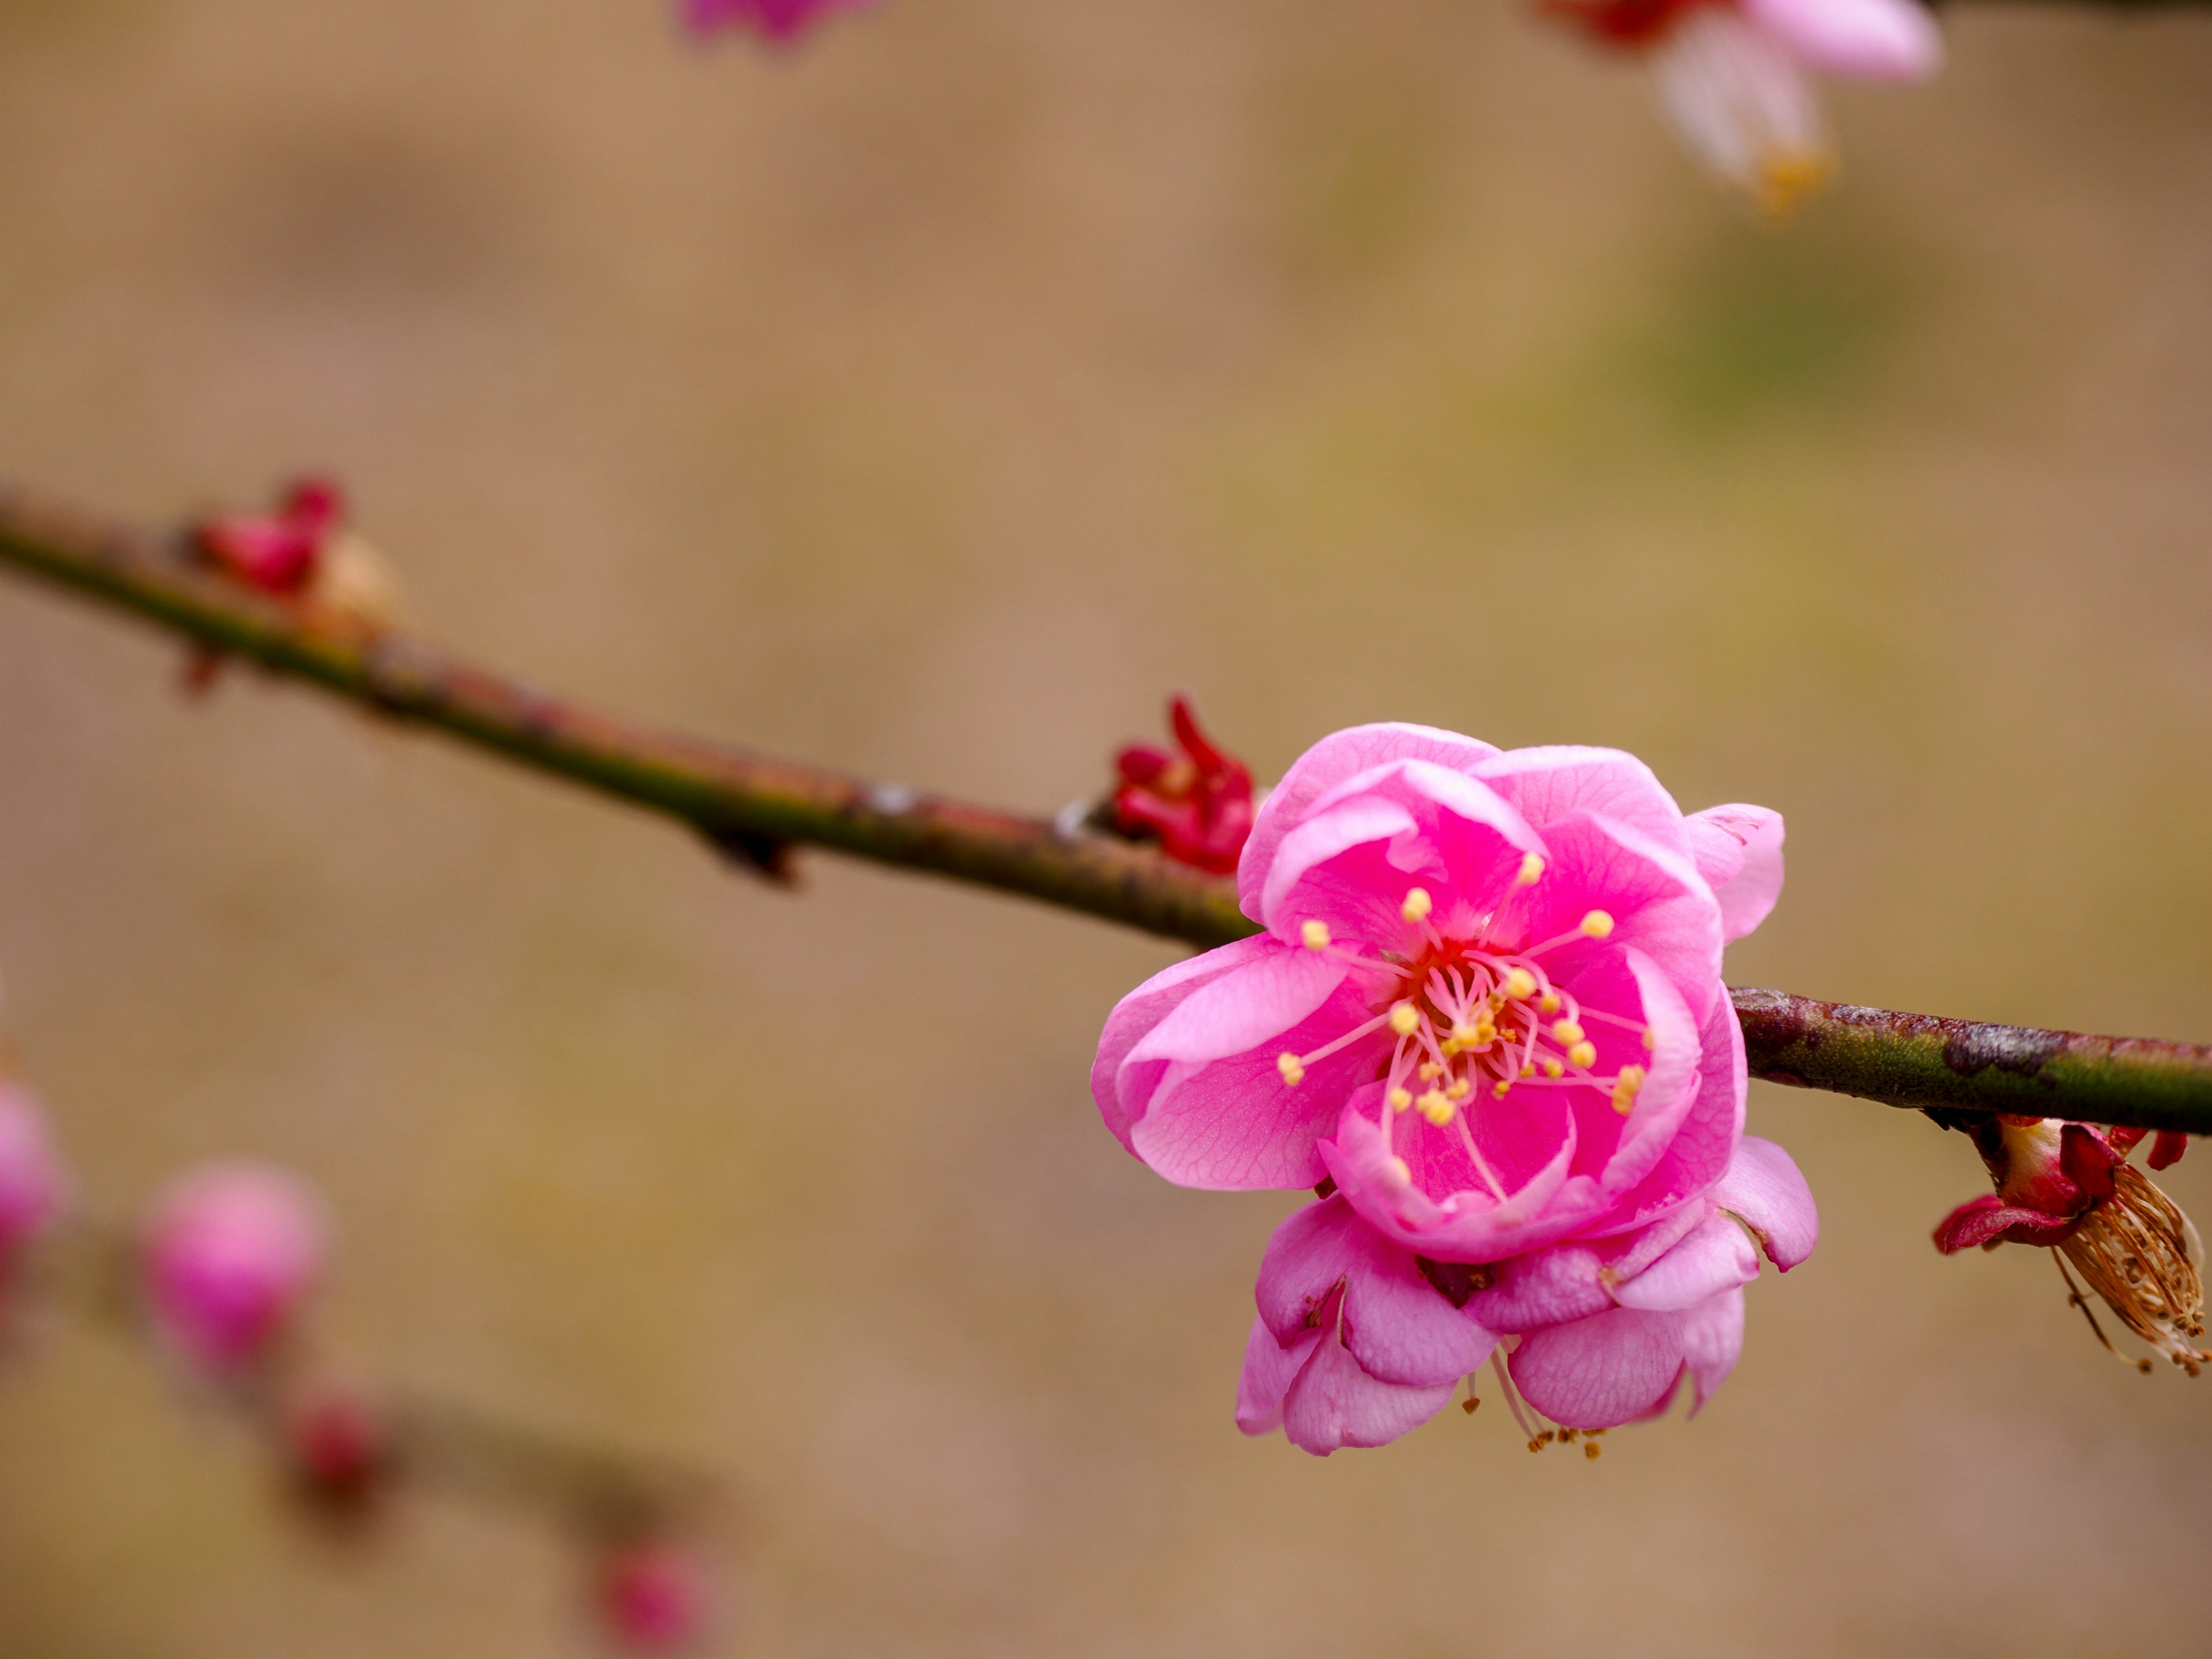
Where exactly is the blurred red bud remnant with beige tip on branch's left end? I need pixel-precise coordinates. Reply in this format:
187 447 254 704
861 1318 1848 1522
192 478 405 642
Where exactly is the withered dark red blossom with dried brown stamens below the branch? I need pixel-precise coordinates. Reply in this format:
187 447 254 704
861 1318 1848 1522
1936 1115 2212 1376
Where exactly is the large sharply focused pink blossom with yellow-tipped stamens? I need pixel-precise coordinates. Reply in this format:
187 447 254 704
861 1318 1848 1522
1090 726 1818 1451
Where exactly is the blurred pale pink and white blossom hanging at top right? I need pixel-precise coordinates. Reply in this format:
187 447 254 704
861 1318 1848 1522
1544 0 1942 213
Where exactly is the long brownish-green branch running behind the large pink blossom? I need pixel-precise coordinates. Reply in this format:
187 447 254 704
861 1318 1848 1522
0 473 2212 1135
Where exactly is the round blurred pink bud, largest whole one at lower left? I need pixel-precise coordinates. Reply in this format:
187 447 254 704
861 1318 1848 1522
144 1164 325 1372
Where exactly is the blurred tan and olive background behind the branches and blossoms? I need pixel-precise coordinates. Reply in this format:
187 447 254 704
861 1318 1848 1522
0 0 2212 1659
